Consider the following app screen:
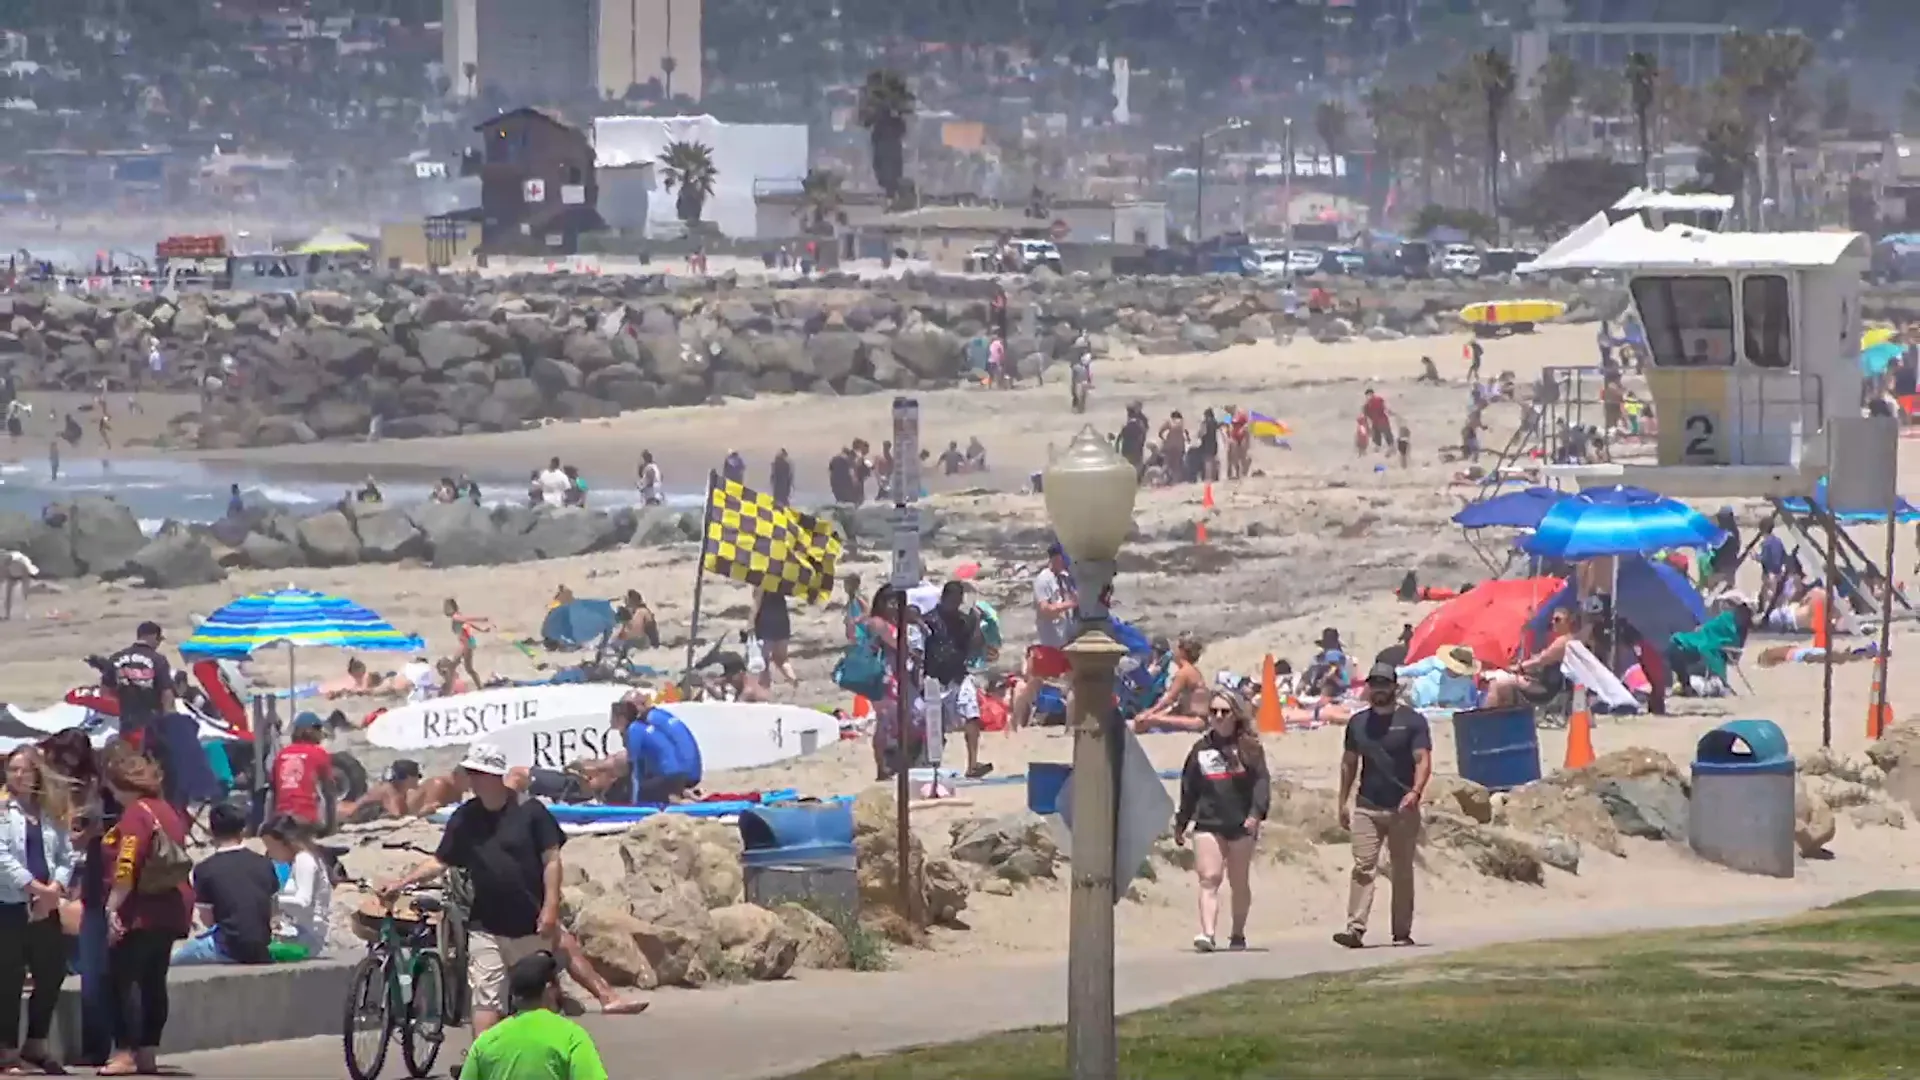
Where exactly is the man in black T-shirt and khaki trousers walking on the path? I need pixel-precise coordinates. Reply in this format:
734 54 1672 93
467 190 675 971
1332 663 1434 949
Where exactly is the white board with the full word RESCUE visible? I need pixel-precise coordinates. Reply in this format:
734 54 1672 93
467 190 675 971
367 682 632 749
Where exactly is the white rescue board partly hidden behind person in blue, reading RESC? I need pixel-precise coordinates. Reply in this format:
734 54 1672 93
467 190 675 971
472 701 839 776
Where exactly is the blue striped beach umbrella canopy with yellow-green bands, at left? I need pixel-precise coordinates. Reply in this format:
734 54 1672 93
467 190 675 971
180 588 426 659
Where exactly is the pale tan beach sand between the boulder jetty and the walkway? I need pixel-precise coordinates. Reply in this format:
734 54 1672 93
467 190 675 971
0 327 1920 965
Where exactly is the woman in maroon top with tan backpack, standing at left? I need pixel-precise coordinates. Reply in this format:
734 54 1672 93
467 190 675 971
100 744 194 1076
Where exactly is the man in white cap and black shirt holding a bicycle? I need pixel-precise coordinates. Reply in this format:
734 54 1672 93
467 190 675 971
380 744 566 1036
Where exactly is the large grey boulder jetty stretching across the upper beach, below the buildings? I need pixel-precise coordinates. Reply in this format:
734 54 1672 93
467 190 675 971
0 273 1622 450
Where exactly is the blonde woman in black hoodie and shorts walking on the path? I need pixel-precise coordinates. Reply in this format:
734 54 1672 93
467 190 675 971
1173 690 1269 953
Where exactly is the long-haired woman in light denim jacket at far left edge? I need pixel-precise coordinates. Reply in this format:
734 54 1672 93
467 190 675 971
0 746 73 1072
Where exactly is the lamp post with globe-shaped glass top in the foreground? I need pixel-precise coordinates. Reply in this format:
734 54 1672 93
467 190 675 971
1043 425 1139 1080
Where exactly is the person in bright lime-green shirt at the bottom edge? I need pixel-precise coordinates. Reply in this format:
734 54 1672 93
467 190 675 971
459 951 607 1080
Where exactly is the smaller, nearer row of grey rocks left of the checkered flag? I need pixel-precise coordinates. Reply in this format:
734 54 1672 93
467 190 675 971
0 496 945 588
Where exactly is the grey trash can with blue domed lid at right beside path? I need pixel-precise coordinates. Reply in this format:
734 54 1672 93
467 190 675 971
1688 721 1797 878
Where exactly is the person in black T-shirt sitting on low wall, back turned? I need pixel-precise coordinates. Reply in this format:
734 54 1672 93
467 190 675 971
173 803 280 967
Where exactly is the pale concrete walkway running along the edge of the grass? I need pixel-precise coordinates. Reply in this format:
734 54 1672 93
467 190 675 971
163 890 1859 1080
